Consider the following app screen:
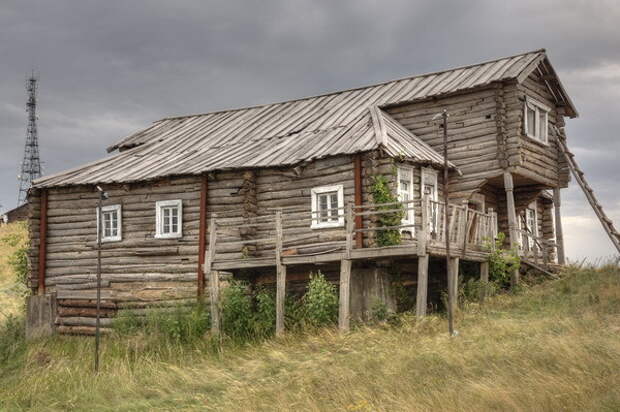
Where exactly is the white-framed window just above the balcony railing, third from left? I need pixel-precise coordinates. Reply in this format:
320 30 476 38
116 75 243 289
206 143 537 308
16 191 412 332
311 185 344 229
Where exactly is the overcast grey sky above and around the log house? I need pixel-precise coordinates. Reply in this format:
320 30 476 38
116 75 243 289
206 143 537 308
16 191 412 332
0 0 620 259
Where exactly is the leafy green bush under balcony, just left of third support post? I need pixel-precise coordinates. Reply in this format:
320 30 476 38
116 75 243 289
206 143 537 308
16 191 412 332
303 271 338 326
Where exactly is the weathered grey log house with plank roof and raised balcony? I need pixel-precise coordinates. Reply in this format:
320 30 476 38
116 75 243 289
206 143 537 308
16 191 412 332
29 50 577 333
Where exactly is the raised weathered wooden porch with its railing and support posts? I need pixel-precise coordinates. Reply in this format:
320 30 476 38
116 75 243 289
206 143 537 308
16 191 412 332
204 197 497 333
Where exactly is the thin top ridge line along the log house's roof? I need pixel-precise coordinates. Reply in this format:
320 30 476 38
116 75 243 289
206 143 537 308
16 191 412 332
153 48 547 123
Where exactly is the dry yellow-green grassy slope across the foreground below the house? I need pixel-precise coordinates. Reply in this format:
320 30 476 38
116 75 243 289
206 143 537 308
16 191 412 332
0 258 620 411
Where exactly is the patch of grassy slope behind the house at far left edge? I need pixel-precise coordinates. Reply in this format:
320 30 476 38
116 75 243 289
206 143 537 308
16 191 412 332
0 222 28 322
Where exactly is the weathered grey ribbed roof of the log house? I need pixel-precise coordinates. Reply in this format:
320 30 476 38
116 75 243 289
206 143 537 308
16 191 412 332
35 50 568 187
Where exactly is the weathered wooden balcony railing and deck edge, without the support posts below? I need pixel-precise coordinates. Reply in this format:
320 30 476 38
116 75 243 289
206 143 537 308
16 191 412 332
205 198 497 272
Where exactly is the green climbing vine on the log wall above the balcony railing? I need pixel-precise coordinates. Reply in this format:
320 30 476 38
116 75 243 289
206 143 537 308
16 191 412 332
370 175 405 246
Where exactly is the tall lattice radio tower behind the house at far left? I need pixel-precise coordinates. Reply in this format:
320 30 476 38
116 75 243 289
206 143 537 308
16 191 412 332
17 72 41 206
